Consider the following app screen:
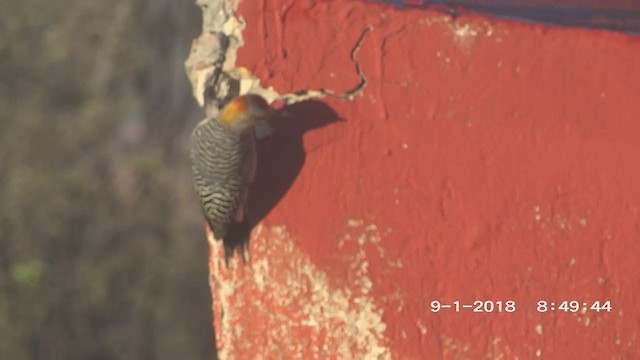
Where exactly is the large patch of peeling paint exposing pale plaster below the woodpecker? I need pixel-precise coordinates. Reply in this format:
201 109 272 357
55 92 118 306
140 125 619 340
210 224 391 359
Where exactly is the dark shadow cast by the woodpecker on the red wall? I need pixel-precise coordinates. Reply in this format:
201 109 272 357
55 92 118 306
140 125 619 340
229 100 344 260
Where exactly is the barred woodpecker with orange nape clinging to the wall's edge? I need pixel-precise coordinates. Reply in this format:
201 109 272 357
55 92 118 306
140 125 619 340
190 94 276 267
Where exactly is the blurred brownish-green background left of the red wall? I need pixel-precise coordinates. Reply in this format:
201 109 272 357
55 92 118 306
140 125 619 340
0 0 213 360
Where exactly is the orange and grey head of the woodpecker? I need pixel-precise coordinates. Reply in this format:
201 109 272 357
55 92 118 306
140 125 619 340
218 94 276 131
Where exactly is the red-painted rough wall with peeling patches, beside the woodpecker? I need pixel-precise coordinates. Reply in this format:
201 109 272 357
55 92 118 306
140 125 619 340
188 0 640 359
